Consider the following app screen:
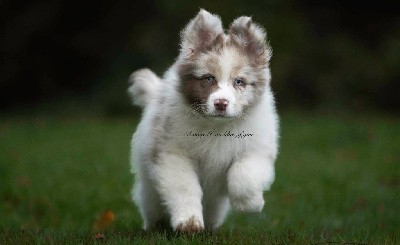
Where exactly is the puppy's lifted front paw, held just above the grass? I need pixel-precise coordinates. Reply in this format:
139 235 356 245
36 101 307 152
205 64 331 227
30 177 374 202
230 193 264 213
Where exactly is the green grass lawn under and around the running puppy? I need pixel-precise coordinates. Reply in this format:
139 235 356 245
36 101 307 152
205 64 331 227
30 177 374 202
0 113 400 244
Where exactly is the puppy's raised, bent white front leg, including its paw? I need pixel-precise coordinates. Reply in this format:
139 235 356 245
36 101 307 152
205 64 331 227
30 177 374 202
228 153 275 212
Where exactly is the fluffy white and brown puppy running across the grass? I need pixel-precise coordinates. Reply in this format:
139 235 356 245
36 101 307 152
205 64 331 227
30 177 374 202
128 10 278 233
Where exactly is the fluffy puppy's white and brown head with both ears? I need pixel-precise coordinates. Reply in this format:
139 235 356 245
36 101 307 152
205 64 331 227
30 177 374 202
178 10 271 118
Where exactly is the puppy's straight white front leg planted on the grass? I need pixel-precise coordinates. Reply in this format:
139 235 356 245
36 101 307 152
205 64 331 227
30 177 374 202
152 153 204 233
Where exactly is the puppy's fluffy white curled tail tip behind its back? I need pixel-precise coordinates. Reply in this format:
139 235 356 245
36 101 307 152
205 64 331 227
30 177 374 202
128 68 161 107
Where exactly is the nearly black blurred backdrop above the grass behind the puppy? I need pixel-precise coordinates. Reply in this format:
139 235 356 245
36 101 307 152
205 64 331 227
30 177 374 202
0 0 400 114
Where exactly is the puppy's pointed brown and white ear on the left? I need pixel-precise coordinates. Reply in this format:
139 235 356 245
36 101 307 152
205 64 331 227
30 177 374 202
181 9 223 57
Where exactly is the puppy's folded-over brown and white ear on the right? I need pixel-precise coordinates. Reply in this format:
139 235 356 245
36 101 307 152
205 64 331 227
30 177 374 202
229 16 272 65
